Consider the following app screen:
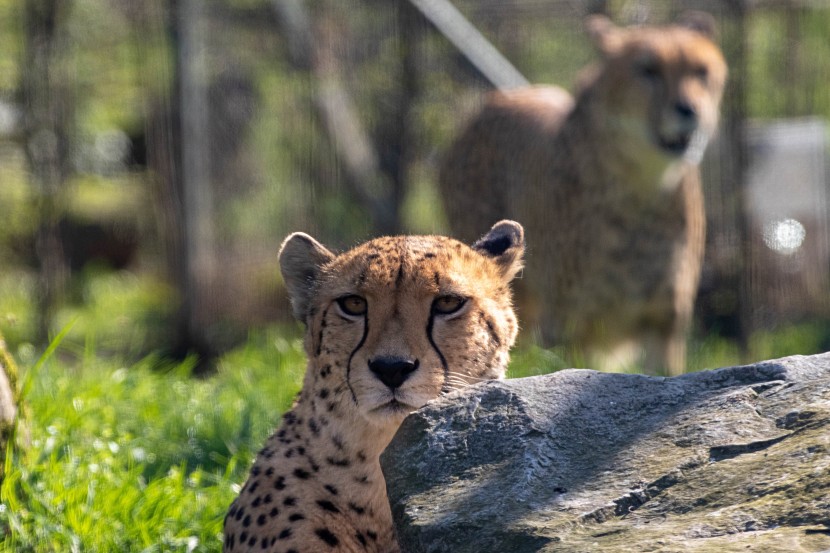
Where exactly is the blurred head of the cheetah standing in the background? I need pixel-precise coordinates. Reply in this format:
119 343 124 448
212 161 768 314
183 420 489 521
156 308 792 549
588 14 727 163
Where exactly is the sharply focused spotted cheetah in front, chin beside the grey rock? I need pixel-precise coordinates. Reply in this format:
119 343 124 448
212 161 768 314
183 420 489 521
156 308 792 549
224 221 525 553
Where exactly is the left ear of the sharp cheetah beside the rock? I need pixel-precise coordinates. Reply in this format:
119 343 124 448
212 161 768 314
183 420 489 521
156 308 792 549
279 232 334 322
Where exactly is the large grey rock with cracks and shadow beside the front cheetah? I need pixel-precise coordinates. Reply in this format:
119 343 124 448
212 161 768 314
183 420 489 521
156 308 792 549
381 354 830 553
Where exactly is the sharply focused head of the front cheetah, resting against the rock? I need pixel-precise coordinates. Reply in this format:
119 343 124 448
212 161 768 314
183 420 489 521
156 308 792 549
280 221 524 425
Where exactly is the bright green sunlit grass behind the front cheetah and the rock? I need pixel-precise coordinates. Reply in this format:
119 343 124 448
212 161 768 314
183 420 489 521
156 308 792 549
0 310 830 552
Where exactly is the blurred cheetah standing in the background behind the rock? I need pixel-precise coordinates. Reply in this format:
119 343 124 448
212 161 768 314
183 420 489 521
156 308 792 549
439 13 727 374
